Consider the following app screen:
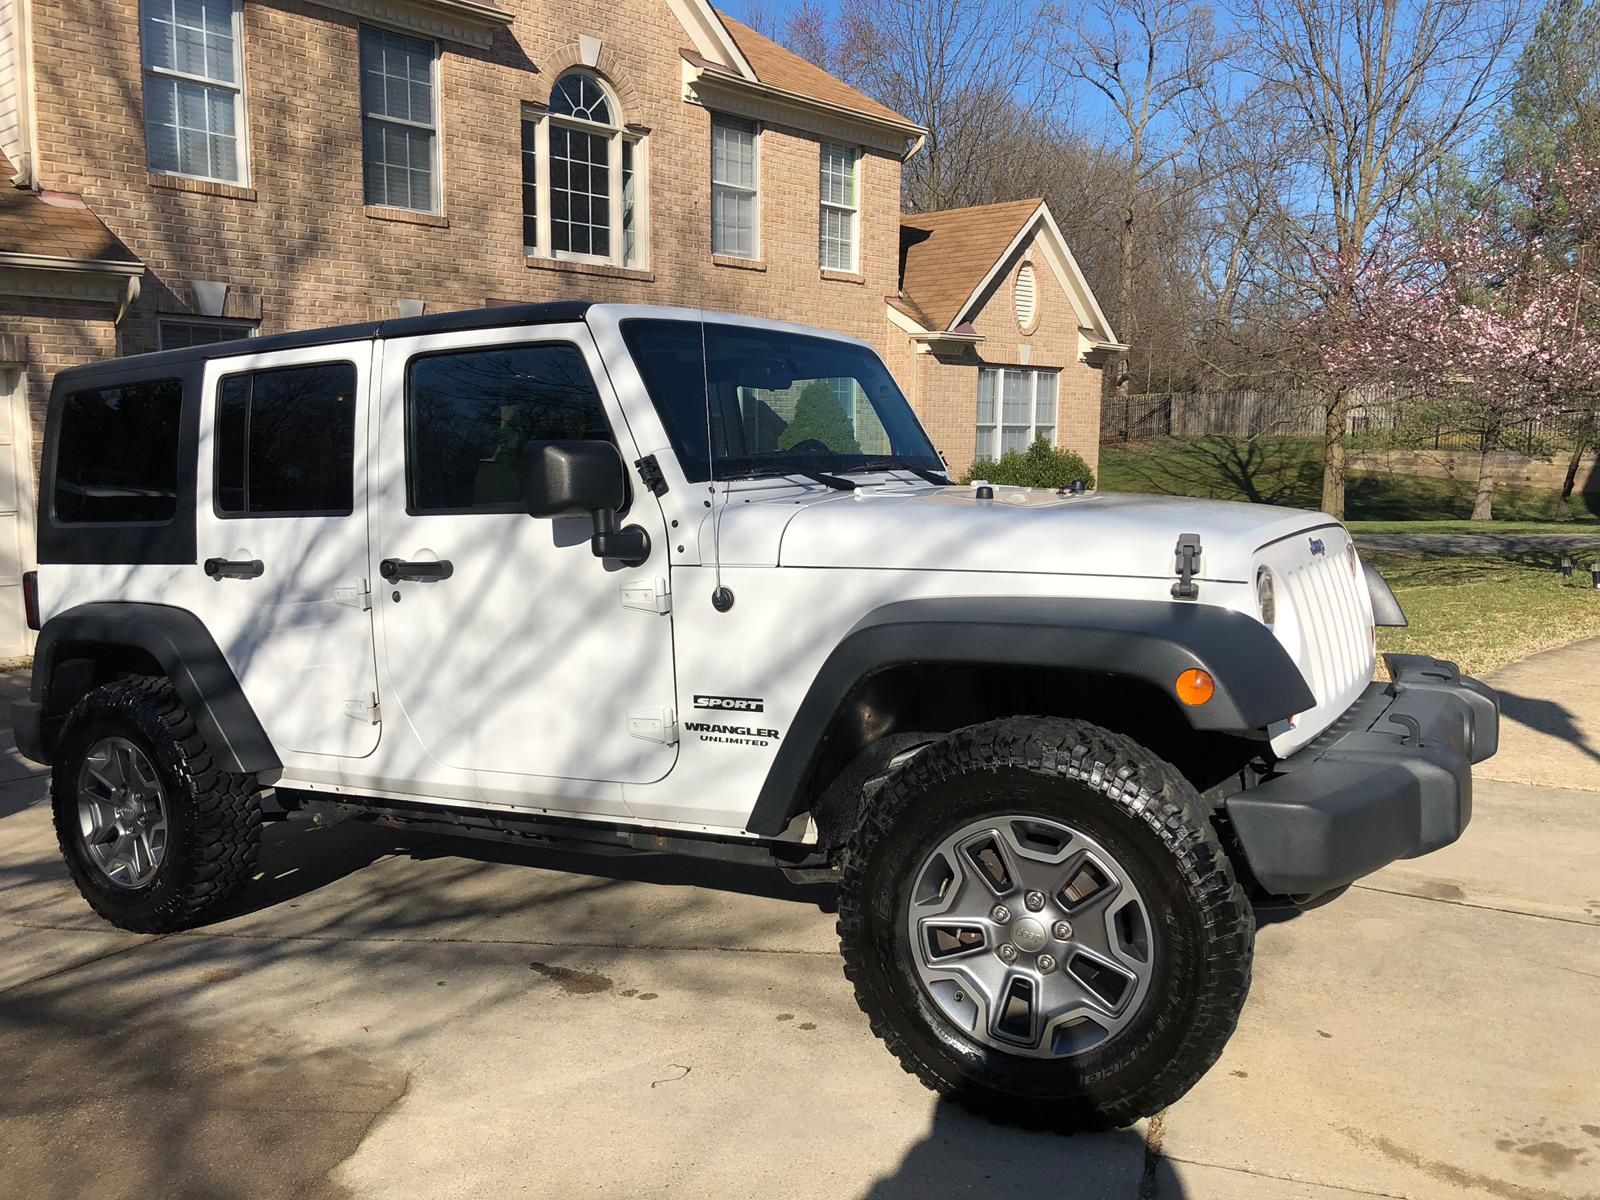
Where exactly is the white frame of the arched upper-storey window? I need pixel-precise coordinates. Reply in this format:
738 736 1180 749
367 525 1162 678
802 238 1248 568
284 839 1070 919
518 69 650 270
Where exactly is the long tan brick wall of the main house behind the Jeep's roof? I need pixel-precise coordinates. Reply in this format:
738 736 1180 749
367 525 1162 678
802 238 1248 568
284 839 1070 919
21 0 901 352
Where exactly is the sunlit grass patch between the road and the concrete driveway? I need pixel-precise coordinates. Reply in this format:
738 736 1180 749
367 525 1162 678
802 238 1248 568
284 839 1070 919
1362 552 1600 675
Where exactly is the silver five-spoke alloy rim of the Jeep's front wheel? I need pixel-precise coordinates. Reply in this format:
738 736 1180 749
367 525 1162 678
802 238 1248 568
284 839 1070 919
906 814 1154 1058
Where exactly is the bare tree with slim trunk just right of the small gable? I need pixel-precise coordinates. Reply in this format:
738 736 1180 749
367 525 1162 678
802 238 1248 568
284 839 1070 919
1043 0 1235 394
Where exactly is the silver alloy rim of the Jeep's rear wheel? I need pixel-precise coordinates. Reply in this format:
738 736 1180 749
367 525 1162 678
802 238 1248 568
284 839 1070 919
78 738 166 888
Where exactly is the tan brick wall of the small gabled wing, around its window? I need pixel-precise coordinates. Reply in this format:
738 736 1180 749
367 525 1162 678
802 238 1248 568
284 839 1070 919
921 235 1101 472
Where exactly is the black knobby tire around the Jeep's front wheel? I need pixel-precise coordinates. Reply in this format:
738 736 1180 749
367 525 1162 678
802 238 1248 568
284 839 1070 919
838 717 1254 1131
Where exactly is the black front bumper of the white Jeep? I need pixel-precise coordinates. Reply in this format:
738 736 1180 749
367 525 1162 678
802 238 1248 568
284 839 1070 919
1224 654 1499 896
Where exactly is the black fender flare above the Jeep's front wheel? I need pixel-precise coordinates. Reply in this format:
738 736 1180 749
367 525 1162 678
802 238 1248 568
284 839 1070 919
746 597 1317 837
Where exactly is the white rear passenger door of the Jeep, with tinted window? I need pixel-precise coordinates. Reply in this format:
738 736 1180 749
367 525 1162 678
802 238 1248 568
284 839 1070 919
195 341 381 757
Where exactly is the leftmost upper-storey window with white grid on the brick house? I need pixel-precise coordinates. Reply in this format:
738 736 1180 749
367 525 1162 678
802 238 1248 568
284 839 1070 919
139 0 246 184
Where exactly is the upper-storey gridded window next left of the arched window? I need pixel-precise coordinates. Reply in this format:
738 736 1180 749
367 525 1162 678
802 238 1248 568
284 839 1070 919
362 26 438 213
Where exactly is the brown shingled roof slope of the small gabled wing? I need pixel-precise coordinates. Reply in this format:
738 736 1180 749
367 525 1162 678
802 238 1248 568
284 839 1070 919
901 200 1043 330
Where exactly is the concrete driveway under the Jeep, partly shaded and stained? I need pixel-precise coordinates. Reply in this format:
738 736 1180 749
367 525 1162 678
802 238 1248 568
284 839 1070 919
0 642 1600 1200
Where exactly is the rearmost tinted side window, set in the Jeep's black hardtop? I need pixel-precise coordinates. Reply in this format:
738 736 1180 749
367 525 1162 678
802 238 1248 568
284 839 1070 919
51 379 184 525
